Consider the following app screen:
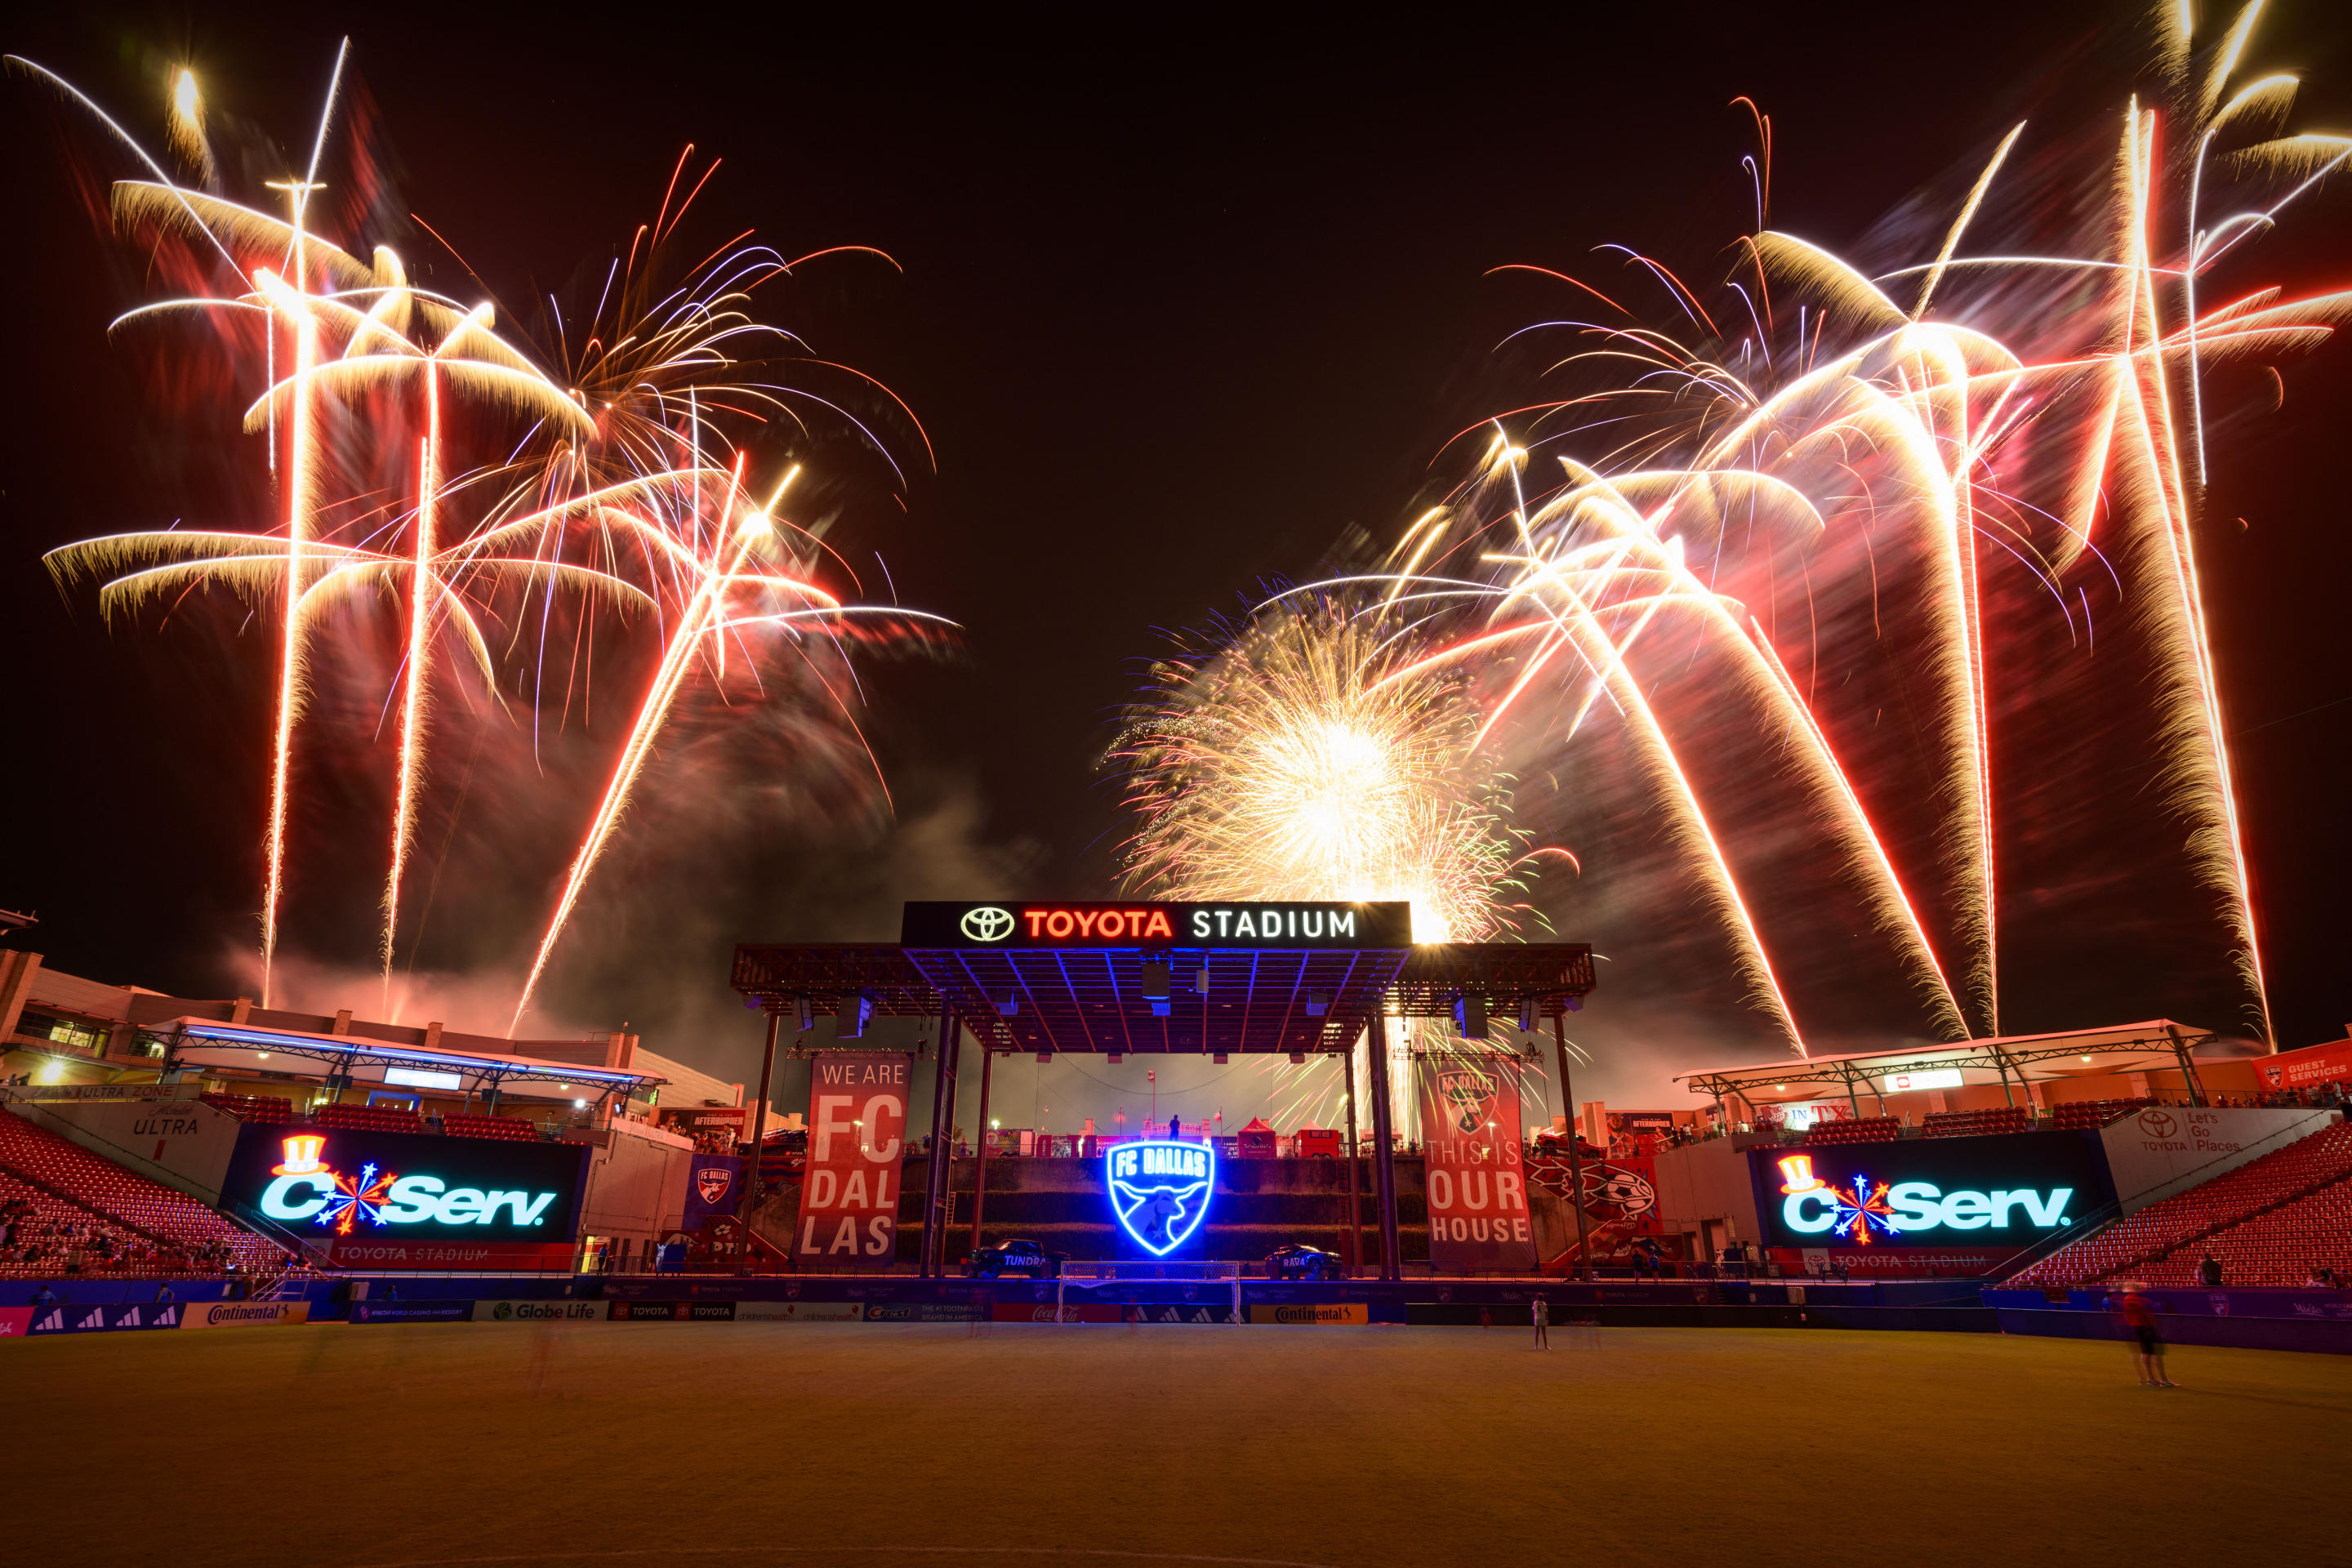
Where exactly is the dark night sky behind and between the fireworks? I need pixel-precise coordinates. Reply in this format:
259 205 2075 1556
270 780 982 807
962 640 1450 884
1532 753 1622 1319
0 0 2352 1114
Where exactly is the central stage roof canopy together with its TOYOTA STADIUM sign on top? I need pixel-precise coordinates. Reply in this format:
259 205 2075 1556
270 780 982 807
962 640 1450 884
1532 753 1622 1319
734 902 1592 1055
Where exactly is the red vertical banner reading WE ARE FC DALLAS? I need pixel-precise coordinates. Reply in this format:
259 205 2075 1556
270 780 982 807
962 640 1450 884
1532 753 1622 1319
793 1051 915 1269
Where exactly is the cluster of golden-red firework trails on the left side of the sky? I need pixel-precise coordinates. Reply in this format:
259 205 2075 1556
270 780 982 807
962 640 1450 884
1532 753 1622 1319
24 40 948 1022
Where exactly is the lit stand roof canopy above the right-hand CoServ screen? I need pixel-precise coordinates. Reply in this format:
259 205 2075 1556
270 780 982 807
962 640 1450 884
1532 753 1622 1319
1675 1018 2242 1105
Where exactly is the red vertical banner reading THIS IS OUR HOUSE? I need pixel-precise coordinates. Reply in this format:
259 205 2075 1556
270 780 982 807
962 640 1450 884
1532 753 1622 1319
1421 1060 1536 1274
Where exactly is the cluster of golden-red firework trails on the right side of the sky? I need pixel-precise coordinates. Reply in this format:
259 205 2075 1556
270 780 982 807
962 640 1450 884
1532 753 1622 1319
1310 7 2352 1051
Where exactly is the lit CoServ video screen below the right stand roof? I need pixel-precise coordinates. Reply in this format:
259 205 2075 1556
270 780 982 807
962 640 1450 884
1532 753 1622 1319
1748 1131 2114 1250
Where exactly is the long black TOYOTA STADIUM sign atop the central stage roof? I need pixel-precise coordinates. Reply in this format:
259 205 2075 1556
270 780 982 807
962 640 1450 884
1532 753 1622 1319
898 900 1414 947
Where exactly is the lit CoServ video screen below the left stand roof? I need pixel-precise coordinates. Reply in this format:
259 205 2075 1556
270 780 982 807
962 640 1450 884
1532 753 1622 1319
221 1124 588 1267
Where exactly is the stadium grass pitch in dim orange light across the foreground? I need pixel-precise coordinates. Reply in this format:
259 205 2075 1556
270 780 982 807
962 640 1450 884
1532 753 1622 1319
0 1324 2352 1568
